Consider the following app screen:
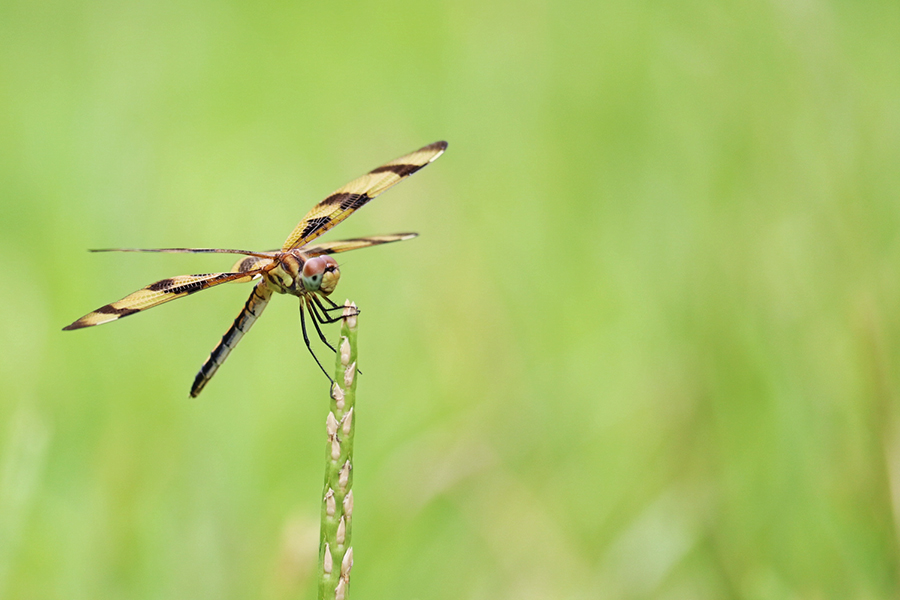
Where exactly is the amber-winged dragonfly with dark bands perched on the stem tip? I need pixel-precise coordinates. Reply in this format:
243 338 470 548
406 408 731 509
63 142 447 398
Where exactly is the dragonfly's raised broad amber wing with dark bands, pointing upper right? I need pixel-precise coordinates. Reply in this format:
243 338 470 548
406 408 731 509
282 142 447 250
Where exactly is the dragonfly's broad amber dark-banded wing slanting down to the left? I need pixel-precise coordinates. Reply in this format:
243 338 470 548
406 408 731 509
63 271 259 331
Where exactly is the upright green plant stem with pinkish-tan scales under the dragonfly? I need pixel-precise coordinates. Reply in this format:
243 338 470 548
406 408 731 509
319 300 357 600
